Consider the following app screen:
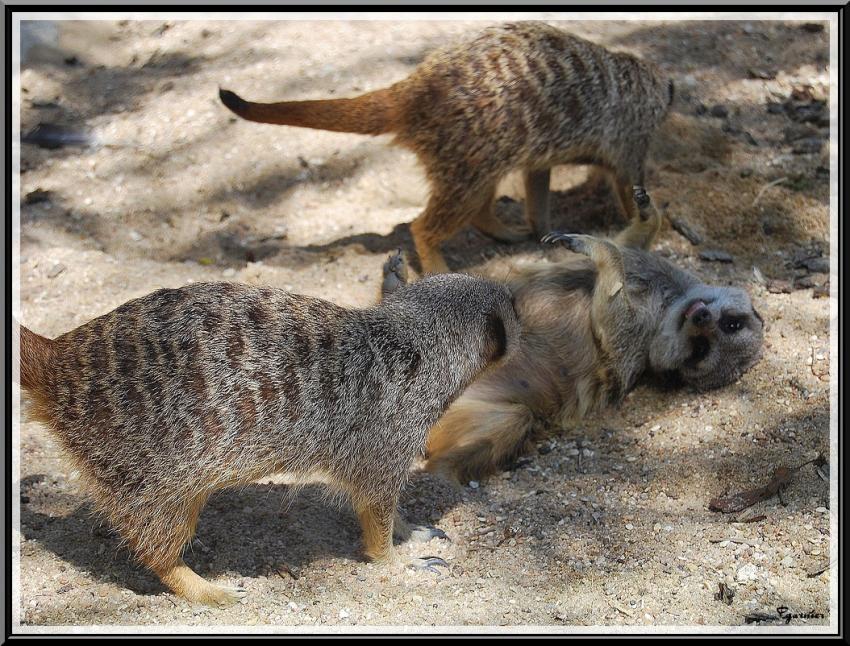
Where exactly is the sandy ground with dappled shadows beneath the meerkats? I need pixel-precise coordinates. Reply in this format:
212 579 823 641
20 16 835 629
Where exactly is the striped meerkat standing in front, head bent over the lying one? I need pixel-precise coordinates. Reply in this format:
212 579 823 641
20 274 519 604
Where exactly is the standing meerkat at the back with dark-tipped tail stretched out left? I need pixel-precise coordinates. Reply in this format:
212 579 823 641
219 22 673 273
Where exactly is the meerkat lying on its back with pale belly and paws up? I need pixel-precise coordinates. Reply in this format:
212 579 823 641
384 187 763 482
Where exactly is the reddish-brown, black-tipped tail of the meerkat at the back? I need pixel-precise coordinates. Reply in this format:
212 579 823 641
218 88 397 135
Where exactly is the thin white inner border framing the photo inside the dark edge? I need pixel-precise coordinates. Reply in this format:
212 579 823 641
9 7 840 634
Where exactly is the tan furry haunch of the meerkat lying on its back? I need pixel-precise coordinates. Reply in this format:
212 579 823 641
425 396 536 483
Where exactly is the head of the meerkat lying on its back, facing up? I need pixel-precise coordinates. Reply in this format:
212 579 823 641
649 284 764 390
